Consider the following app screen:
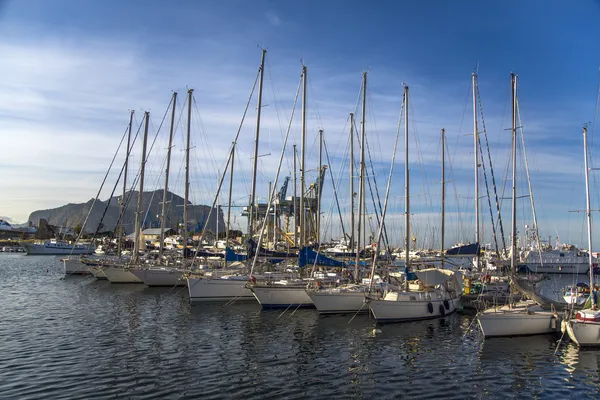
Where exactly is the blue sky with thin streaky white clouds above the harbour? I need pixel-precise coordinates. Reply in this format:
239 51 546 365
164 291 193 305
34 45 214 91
0 0 600 248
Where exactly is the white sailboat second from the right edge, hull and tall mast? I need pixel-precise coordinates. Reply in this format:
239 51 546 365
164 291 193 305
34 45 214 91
477 74 558 338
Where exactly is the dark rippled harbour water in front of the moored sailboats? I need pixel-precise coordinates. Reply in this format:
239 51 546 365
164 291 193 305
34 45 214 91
0 254 600 399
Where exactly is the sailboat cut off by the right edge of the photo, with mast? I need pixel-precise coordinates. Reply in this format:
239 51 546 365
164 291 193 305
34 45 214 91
563 127 600 346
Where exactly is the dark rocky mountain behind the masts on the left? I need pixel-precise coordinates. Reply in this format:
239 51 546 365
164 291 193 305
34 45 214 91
29 190 225 234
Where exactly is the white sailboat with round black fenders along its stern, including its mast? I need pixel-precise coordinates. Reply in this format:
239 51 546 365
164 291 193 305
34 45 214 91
368 85 462 322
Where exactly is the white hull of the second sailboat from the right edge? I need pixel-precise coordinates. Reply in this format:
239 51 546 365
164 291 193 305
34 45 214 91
477 306 559 337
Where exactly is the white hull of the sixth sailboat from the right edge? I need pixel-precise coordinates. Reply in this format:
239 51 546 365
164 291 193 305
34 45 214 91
187 277 254 301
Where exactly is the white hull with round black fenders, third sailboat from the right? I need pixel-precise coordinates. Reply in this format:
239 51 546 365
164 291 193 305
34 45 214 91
369 292 459 322
